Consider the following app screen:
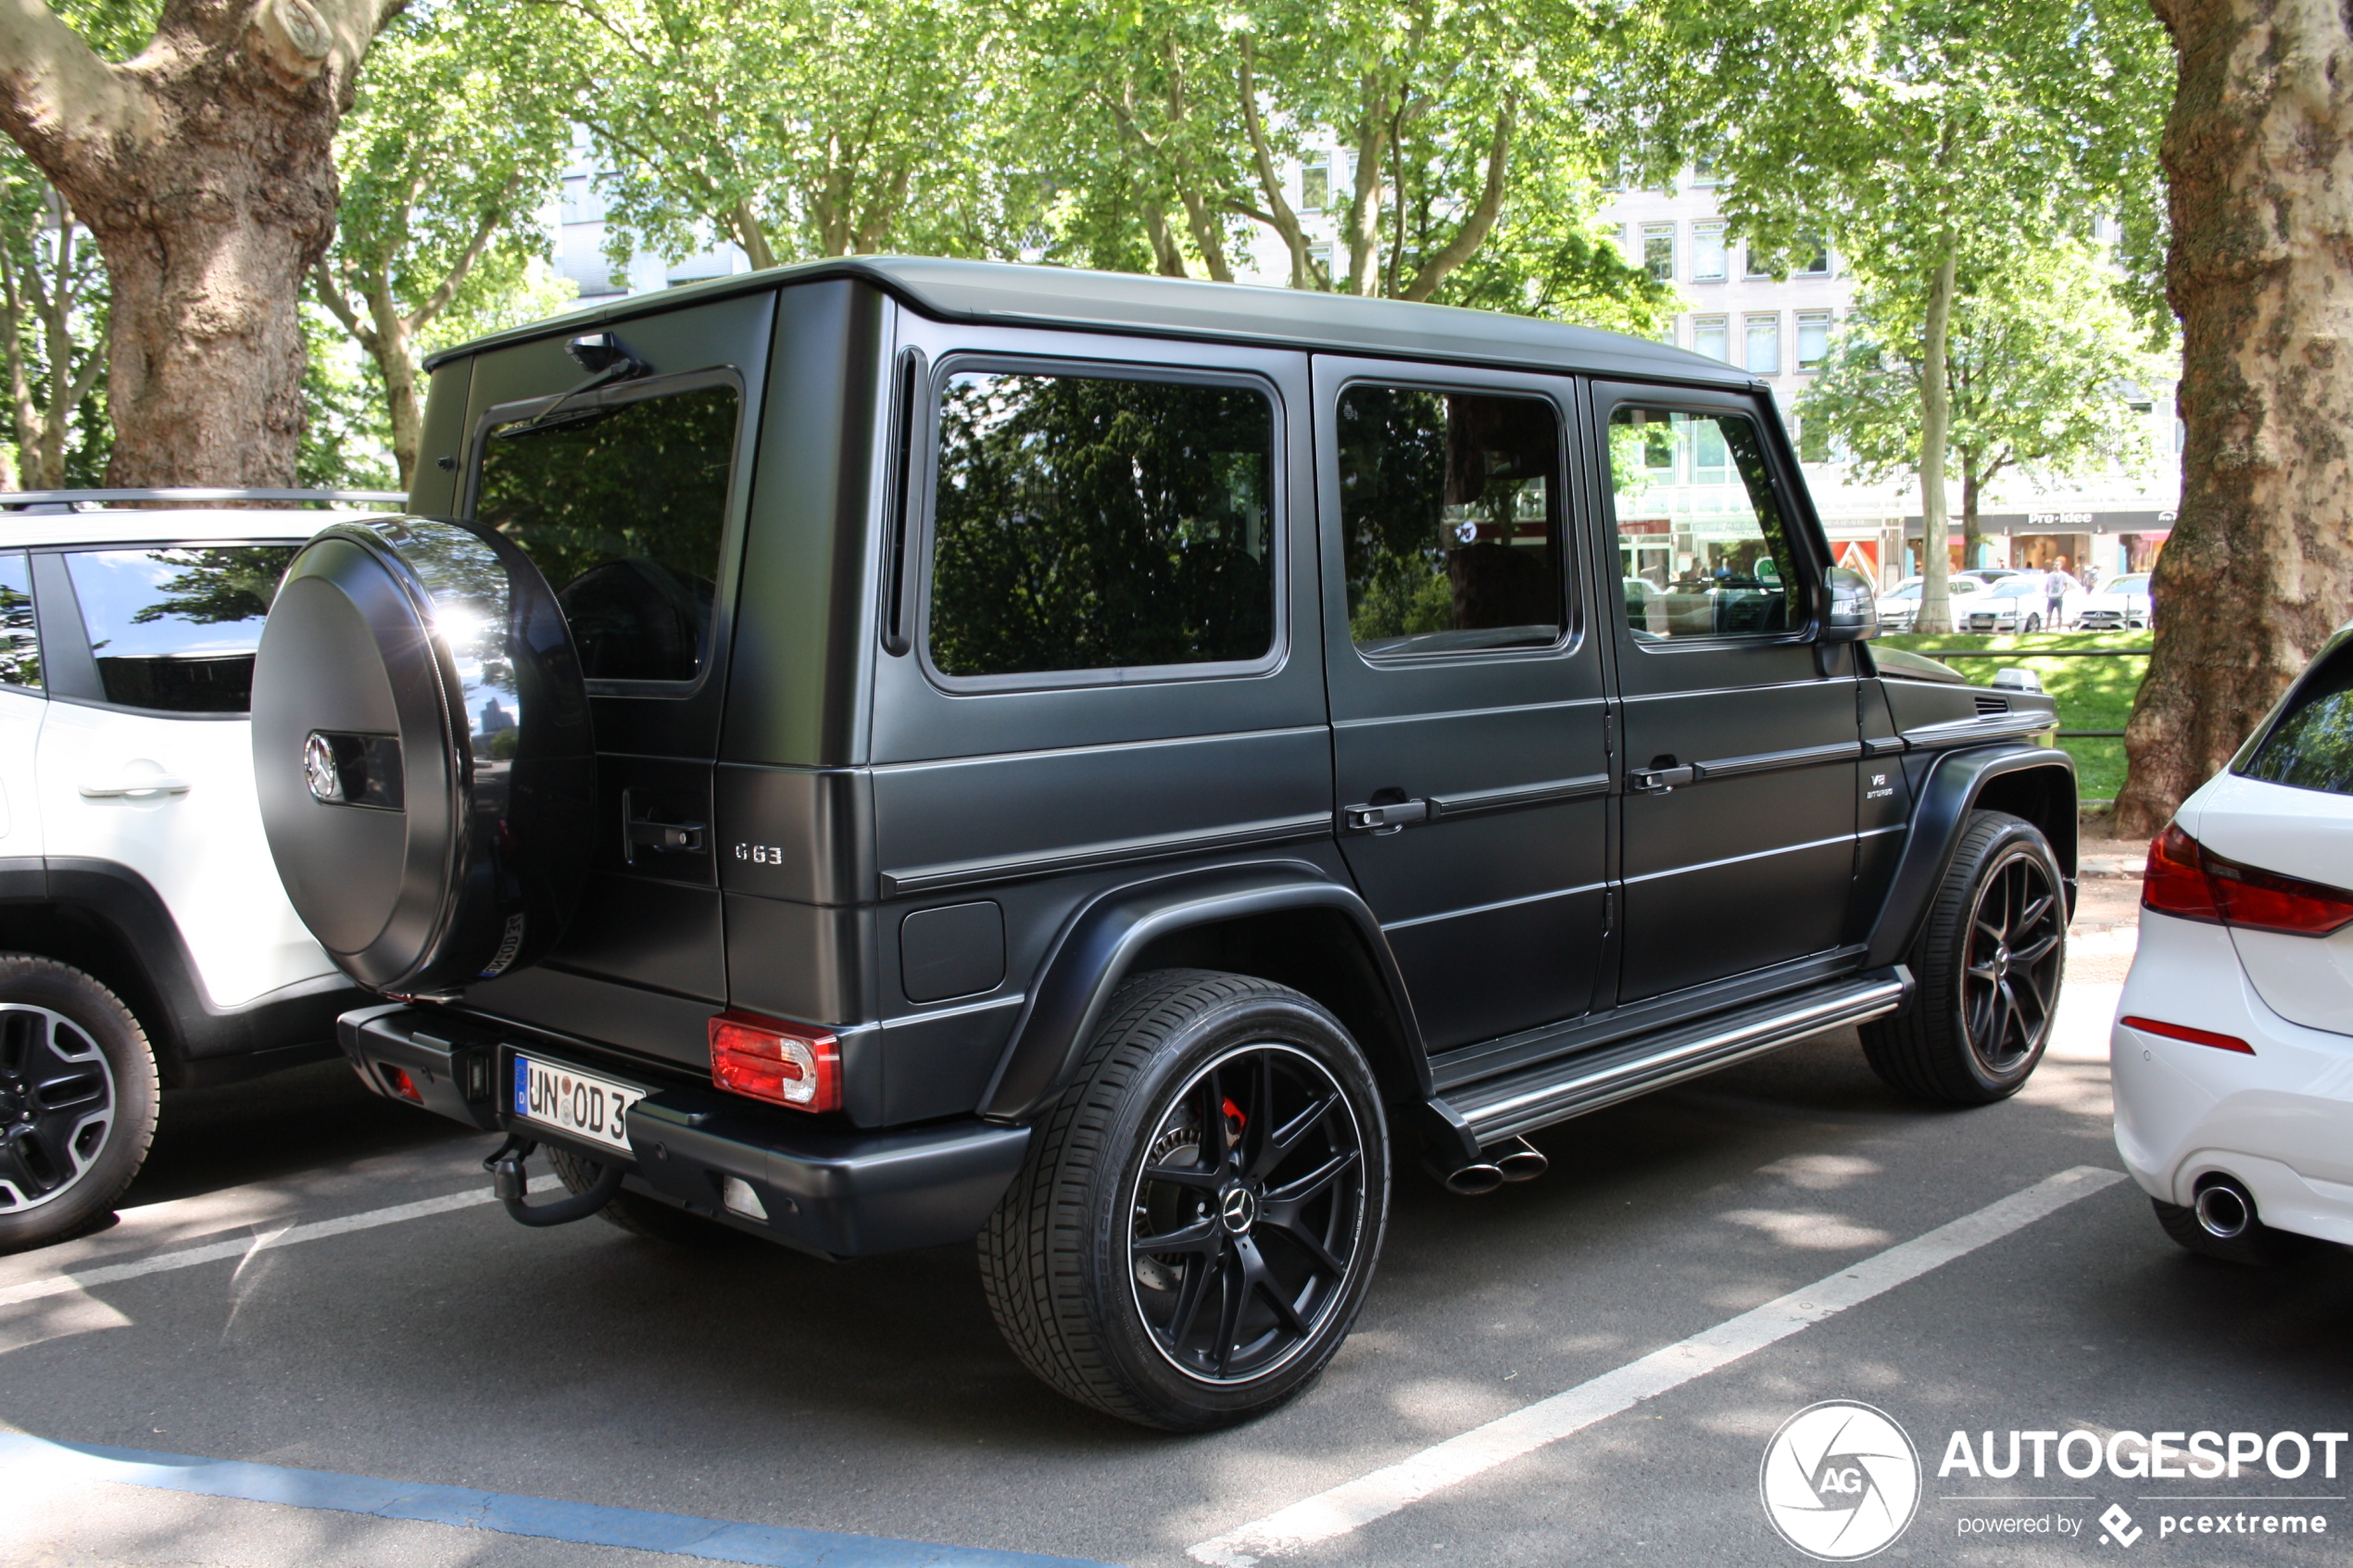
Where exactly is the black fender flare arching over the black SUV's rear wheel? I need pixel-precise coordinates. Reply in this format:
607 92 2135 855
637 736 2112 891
981 860 1433 1122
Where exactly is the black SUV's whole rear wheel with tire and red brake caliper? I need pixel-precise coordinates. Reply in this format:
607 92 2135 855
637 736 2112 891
979 971 1389 1432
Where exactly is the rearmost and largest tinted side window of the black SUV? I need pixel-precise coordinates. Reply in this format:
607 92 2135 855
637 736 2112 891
929 371 1276 674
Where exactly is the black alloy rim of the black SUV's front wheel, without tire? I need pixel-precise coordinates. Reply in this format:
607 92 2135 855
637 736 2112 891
1960 844 2066 1079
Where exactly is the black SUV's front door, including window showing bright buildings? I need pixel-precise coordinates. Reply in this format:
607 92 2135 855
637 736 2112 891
1593 383 1864 1001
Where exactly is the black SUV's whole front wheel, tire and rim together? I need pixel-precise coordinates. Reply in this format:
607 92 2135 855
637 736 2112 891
1861 811 2069 1105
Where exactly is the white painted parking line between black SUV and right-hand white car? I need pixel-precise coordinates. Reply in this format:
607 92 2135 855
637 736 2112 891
1189 1166 2125 1568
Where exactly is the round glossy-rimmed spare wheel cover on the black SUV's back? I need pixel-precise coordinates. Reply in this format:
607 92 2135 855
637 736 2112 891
252 517 596 997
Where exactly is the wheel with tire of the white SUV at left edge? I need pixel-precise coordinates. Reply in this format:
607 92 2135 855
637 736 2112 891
0 952 157 1253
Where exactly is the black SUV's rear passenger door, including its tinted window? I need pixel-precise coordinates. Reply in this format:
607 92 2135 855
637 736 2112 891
1315 358 1609 1051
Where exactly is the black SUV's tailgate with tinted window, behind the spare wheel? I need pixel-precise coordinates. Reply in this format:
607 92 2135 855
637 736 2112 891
435 294 774 1062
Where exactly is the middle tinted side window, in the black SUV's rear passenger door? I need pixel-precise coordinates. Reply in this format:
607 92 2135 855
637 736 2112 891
1339 385 1563 654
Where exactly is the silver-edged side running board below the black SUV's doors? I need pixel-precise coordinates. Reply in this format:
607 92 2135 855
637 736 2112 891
1445 966 1910 1145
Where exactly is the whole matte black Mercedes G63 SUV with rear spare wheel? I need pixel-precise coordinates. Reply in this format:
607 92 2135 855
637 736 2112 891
254 258 2075 1429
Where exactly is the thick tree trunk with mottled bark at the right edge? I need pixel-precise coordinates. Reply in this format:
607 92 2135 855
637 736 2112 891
2115 0 2353 837
